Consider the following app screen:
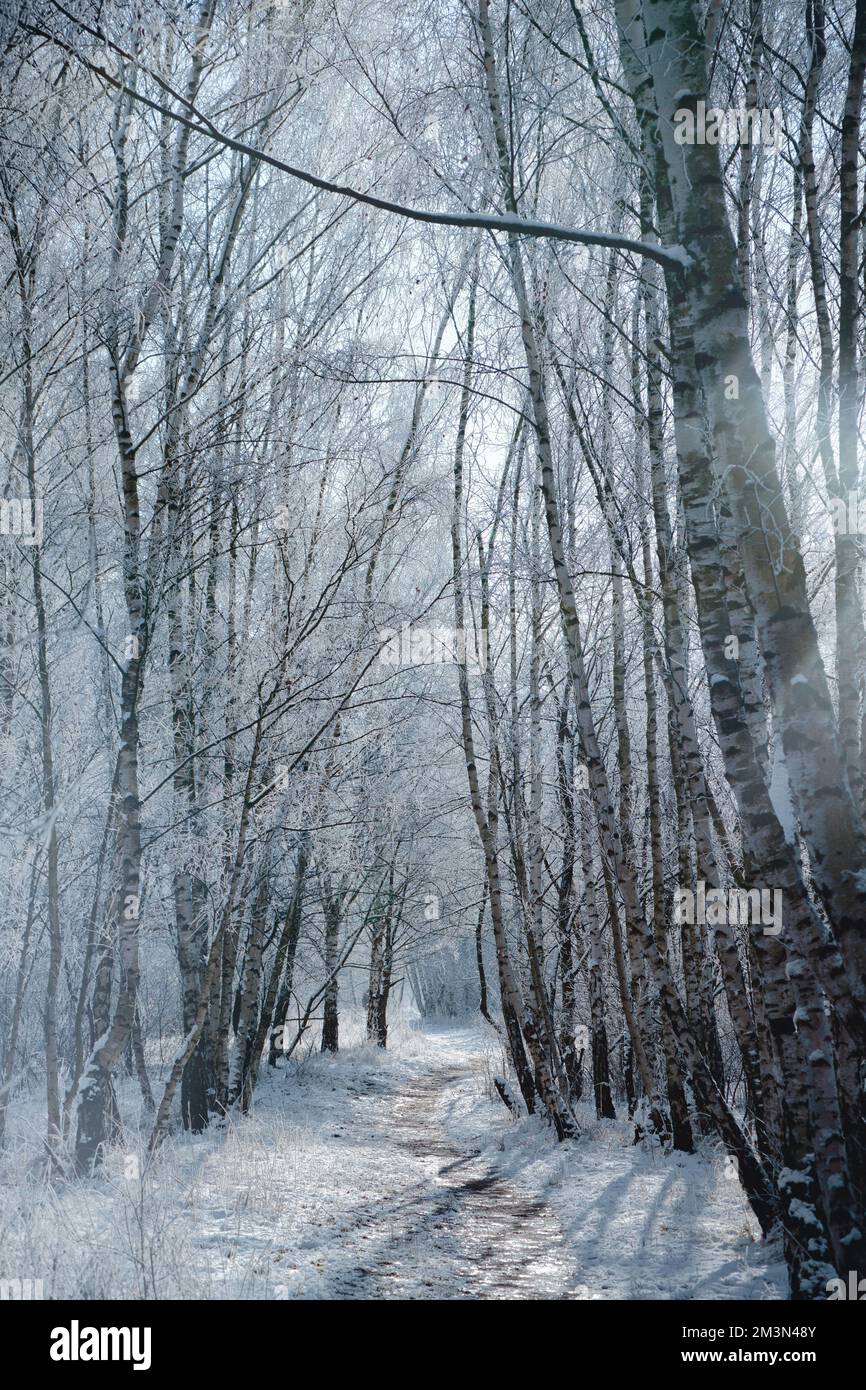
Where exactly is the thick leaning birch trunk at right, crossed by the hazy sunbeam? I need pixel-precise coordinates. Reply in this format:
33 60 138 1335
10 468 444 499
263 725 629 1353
642 0 866 1006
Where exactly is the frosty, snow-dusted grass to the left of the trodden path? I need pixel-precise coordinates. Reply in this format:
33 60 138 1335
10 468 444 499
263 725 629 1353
0 1013 447 1298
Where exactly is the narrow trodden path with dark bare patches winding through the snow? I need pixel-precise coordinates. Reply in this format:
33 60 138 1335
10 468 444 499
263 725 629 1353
311 1030 587 1300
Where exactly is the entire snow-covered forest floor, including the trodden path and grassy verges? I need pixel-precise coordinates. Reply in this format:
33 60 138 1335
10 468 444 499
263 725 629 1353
0 1023 785 1300
